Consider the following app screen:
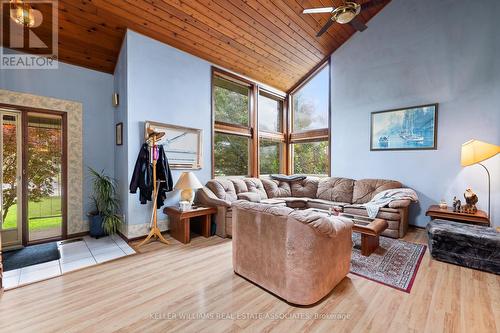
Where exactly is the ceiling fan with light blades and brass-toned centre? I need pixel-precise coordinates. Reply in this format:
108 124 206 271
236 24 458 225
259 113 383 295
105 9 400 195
302 0 387 37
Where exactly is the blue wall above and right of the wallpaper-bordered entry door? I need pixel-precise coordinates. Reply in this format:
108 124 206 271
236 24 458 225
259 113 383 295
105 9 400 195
0 51 115 228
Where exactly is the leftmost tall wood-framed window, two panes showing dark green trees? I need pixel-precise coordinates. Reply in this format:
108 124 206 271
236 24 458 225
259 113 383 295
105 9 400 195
212 74 253 177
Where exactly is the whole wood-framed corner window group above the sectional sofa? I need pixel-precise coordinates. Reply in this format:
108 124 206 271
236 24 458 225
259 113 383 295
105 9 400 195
212 64 330 177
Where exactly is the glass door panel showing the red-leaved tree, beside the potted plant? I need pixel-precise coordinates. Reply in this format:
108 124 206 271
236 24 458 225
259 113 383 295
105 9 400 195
26 112 63 242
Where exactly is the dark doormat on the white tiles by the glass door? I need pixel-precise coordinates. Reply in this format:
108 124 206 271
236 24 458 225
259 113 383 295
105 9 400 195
2 242 61 271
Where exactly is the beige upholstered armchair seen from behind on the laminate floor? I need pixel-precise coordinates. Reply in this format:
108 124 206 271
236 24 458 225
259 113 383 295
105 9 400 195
232 201 353 305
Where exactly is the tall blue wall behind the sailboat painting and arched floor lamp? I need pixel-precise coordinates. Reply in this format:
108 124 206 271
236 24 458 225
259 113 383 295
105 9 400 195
331 0 500 226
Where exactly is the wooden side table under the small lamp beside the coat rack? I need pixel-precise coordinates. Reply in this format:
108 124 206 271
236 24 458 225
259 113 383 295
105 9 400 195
163 207 217 244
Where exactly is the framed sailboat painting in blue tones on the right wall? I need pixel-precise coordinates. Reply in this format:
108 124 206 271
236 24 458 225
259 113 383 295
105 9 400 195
370 104 438 150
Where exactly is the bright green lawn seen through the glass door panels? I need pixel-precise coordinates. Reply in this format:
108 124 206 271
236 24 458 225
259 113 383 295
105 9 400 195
3 197 62 230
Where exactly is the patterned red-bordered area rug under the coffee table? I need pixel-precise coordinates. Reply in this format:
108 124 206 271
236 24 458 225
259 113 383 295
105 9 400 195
351 233 427 293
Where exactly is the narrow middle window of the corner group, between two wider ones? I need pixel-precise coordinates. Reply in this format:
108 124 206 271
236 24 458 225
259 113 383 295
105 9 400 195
258 91 285 175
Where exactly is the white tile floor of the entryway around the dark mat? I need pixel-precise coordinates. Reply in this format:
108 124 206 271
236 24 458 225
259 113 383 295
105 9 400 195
3 235 135 289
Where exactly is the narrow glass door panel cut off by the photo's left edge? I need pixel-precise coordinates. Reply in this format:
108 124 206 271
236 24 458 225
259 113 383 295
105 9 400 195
0 109 23 247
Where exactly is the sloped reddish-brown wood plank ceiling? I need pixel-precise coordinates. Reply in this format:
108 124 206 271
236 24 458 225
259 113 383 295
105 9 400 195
4 0 390 91
